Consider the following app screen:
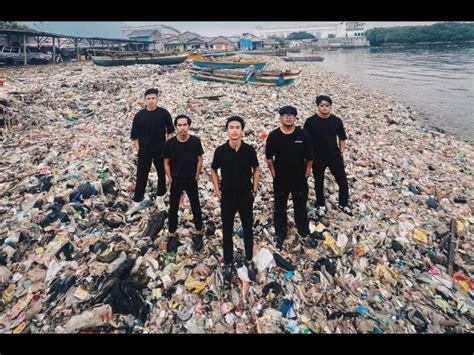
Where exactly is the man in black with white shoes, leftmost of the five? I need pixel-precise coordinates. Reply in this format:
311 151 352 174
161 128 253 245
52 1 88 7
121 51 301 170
130 89 174 210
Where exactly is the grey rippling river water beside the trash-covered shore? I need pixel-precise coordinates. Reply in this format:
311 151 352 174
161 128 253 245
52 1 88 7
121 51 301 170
295 45 474 143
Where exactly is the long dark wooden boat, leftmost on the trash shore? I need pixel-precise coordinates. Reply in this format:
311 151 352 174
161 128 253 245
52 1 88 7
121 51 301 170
93 53 187 67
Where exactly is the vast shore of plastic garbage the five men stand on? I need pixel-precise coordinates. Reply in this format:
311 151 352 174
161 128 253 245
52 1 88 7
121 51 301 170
0 58 474 333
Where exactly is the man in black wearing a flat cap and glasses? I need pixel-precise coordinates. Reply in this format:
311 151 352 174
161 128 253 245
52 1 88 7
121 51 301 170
265 106 313 249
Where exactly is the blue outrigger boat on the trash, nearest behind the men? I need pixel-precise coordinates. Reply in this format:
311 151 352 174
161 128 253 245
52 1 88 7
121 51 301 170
190 68 301 86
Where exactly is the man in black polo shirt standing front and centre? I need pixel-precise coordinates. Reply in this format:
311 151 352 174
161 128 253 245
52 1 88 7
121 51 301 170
211 116 260 287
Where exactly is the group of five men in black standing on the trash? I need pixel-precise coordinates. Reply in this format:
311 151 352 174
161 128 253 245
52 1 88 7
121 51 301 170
129 89 352 283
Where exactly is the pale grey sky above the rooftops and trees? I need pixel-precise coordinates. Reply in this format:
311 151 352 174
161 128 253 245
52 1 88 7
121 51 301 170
126 21 436 36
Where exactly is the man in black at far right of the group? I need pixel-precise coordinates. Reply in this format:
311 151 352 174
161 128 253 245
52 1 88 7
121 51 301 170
304 95 352 216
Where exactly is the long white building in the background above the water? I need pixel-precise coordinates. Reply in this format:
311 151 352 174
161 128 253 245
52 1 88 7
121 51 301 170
256 21 365 39
